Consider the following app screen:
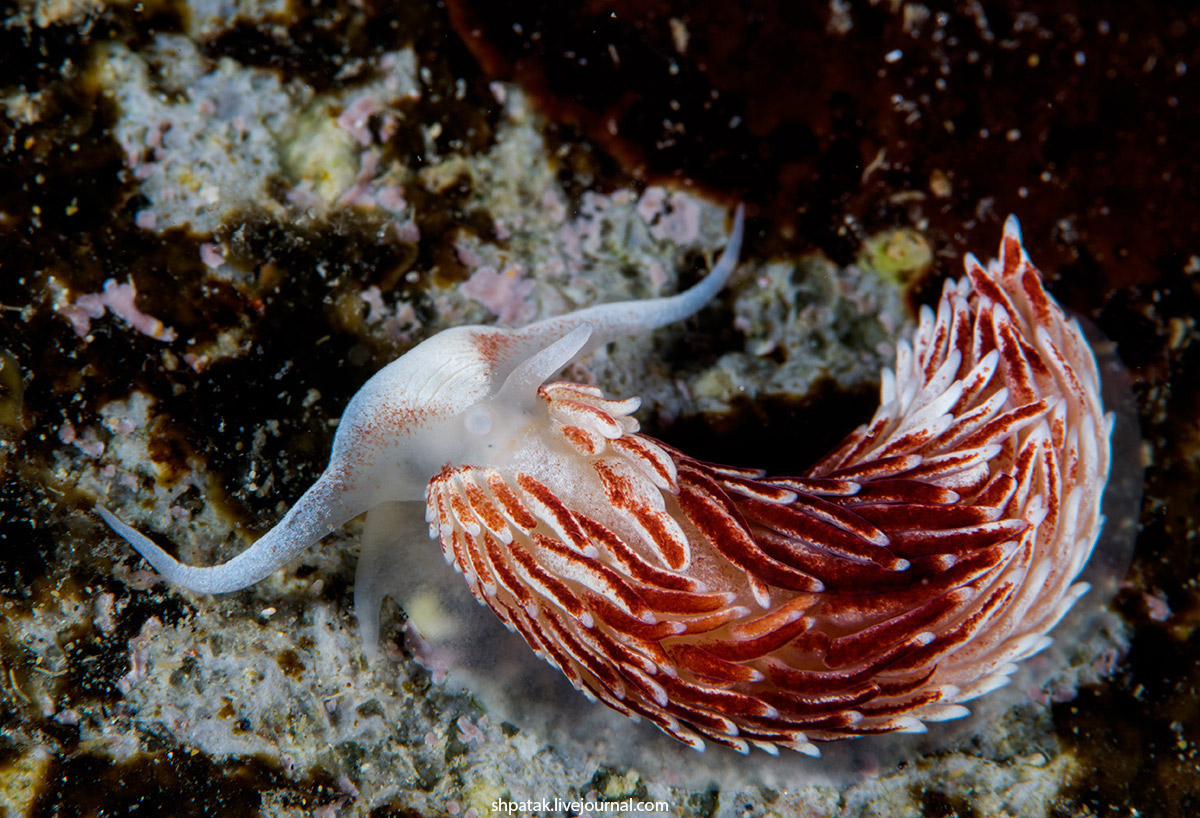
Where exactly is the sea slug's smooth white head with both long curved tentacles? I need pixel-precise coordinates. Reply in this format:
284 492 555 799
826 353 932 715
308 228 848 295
96 207 743 594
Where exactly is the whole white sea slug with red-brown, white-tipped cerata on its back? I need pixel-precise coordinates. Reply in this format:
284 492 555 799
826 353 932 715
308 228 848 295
98 209 1112 754
